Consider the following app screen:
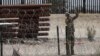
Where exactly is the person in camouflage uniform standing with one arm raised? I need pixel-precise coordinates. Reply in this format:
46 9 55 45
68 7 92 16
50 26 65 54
65 11 79 55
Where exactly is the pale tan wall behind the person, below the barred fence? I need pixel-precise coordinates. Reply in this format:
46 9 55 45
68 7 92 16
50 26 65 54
49 14 100 38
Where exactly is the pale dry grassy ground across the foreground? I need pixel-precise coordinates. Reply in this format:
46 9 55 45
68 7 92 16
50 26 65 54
4 39 100 56
